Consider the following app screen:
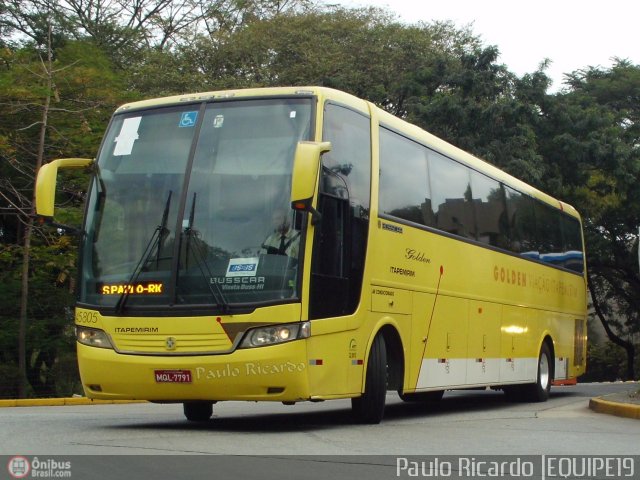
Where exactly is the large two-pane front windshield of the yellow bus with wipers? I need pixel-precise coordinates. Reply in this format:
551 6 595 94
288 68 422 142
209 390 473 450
79 97 312 312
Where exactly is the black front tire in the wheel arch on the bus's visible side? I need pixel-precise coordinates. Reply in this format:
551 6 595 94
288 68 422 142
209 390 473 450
351 334 387 424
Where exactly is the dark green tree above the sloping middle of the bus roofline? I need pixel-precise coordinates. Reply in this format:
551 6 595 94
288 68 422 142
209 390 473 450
409 44 550 185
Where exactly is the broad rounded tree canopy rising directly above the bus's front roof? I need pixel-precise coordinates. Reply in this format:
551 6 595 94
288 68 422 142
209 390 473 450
168 7 479 108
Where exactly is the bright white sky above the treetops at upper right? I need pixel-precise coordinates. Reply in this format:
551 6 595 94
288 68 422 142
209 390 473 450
330 0 640 91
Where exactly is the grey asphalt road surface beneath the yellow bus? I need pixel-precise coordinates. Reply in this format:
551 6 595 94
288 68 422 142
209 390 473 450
0 383 640 480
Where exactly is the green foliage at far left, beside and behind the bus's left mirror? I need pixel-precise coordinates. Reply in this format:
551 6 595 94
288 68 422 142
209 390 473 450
0 39 125 396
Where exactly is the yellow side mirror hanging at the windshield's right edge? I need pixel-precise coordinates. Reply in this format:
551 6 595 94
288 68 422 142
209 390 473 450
291 142 331 223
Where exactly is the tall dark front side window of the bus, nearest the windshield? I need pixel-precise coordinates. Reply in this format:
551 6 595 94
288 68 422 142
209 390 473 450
309 103 371 318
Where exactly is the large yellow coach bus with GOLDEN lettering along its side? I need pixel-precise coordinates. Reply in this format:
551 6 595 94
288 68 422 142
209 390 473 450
36 87 587 423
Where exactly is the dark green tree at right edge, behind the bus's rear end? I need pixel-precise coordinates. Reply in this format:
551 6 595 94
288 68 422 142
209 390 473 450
538 60 640 379
